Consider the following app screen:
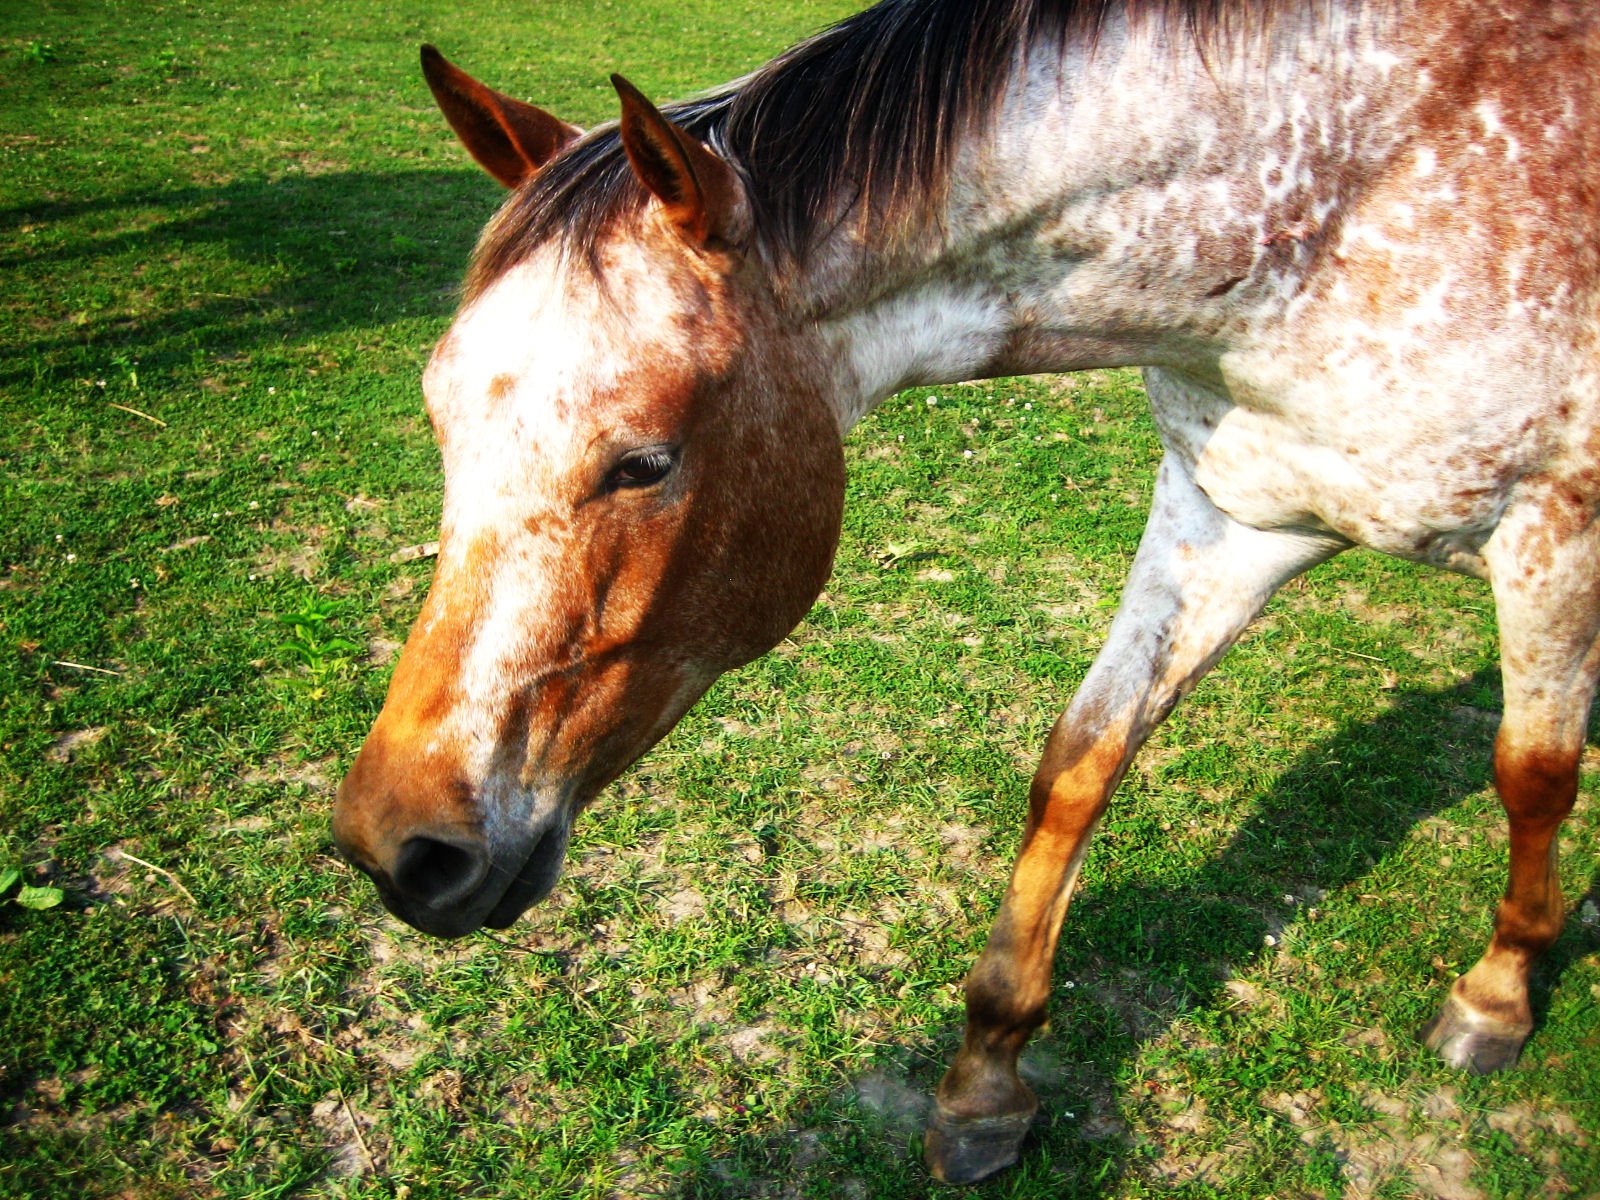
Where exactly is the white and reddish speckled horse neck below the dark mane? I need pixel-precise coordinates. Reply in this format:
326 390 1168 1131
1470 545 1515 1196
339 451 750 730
800 2 1406 427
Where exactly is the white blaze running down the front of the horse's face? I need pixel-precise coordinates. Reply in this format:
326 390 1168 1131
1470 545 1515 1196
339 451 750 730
418 250 694 782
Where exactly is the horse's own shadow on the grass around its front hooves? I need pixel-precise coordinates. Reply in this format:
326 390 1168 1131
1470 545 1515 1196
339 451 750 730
659 670 1600 1198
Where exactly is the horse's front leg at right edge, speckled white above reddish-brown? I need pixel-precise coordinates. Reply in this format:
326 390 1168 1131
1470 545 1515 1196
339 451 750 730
1424 509 1600 1075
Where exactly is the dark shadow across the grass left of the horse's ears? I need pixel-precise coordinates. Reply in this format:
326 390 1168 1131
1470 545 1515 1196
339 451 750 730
0 170 499 384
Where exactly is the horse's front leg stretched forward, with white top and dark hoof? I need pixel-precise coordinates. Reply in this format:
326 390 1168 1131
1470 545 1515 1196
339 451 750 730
923 458 1344 1182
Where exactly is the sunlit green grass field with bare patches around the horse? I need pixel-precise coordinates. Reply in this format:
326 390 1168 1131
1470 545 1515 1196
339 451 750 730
0 0 1600 1200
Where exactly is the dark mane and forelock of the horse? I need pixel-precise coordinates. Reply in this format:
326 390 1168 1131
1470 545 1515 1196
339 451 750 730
466 0 1318 301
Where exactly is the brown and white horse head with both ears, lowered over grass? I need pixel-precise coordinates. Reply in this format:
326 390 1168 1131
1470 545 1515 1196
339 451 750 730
334 48 843 936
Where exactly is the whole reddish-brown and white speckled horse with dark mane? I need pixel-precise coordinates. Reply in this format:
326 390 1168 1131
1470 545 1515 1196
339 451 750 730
333 0 1600 1182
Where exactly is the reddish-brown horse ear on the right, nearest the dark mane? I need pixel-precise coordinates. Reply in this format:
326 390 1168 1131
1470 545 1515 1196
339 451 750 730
611 75 750 250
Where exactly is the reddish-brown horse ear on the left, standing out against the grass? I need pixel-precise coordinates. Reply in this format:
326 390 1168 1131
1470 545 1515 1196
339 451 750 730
422 46 584 187
